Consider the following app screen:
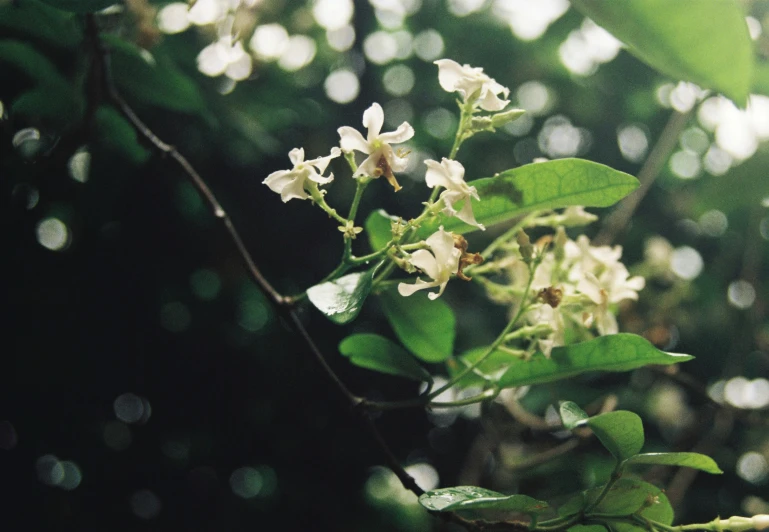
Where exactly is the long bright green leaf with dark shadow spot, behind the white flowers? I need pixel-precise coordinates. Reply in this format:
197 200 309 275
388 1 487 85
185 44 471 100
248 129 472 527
419 159 638 237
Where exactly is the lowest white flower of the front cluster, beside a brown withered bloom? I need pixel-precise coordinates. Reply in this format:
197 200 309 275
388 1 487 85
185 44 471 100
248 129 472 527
398 226 462 300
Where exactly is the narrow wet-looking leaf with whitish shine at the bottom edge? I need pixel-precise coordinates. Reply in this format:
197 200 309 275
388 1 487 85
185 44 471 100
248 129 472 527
419 486 548 515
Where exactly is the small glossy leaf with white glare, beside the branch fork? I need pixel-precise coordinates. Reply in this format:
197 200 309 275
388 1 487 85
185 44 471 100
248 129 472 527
307 268 376 325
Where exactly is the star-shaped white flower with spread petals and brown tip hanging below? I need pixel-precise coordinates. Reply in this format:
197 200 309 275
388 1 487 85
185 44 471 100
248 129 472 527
337 103 414 190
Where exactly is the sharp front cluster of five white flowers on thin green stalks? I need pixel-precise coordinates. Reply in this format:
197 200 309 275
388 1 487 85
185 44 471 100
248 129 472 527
263 59 521 299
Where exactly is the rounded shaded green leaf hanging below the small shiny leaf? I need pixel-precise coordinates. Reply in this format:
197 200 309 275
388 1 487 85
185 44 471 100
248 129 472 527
380 291 456 362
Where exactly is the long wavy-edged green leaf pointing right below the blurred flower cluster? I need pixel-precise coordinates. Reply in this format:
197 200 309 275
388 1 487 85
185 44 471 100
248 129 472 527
498 333 694 388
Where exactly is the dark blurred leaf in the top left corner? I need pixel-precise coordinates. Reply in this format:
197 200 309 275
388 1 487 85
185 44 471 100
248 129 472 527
0 0 83 48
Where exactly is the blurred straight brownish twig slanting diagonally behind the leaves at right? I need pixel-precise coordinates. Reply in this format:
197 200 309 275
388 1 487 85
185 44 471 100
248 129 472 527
593 108 694 245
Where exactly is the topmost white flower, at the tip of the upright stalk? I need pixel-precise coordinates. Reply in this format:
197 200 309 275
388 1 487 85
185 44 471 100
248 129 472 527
435 59 510 111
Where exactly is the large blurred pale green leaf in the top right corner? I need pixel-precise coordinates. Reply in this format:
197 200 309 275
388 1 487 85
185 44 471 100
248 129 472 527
572 0 753 105
